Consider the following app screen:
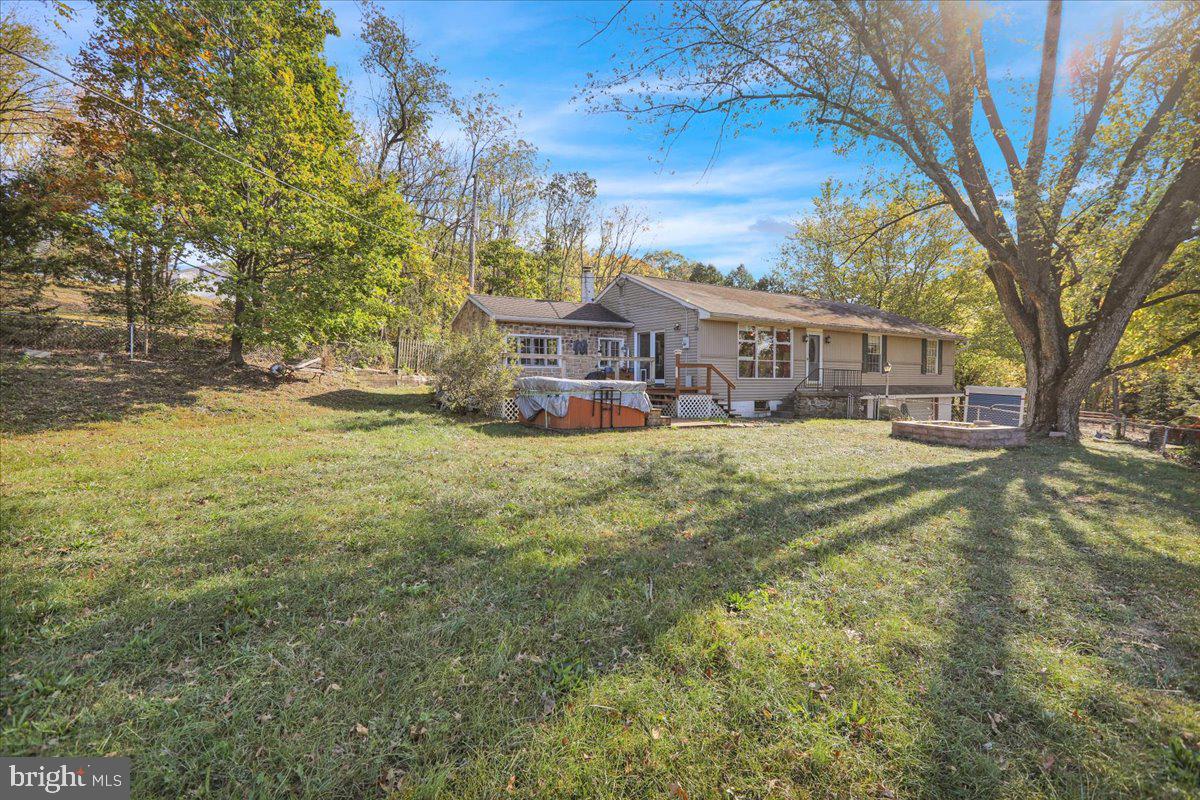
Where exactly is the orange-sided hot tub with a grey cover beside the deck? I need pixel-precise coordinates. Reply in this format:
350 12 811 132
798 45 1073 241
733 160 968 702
516 377 650 431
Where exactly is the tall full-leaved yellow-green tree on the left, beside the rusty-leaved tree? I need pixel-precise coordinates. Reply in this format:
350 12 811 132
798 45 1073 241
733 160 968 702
109 0 414 363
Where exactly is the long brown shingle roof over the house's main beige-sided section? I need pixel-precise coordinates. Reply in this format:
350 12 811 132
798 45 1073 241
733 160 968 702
624 275 966 339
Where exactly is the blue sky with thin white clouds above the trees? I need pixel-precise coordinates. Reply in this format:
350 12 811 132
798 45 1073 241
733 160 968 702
23 0 1129 275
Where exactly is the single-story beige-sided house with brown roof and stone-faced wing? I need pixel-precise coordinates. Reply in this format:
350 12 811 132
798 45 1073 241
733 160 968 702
451 273 964 419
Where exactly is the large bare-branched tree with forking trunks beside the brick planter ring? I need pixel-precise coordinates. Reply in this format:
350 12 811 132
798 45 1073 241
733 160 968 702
593 0 1200 434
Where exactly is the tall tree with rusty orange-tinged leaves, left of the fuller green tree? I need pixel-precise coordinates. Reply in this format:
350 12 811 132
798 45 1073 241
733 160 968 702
66 0 197 351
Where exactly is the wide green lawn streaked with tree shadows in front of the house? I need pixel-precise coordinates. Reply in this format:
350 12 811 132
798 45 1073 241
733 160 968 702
0 362 1200 799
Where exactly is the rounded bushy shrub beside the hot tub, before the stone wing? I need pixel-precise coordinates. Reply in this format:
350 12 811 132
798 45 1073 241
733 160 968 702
433 325 520 414
